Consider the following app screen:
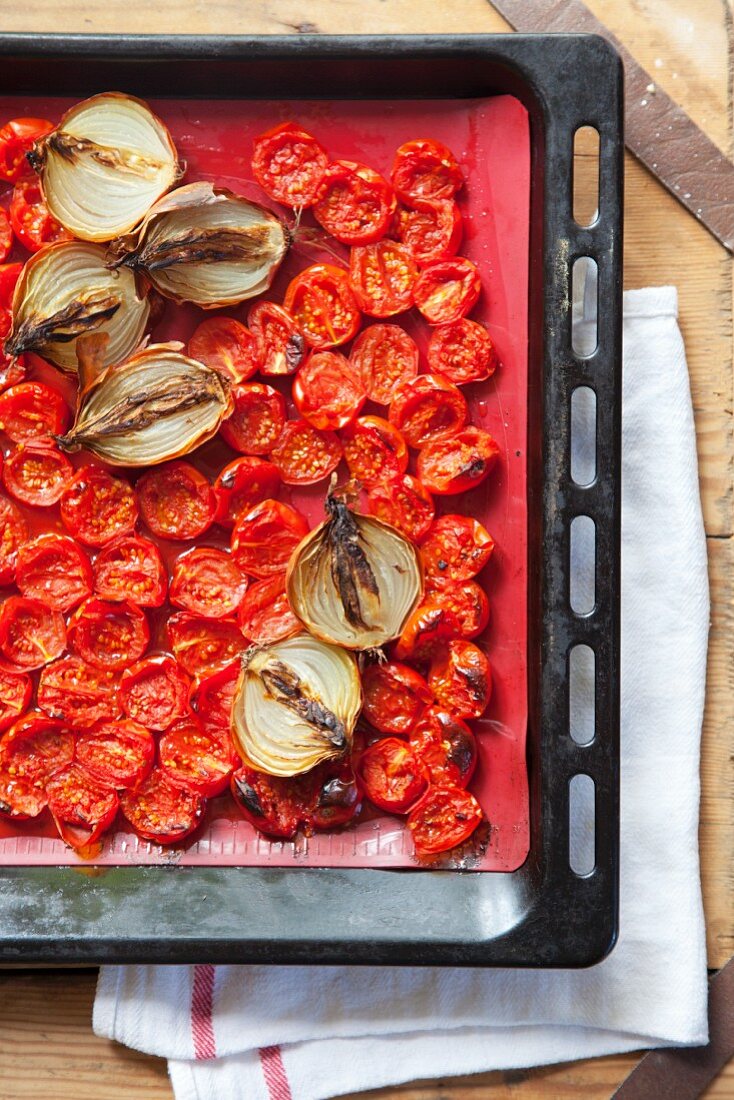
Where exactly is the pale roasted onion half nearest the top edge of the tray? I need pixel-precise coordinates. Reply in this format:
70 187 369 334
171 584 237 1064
29 91 182 241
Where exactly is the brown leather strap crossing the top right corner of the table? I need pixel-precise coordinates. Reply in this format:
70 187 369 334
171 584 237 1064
492 0 734 252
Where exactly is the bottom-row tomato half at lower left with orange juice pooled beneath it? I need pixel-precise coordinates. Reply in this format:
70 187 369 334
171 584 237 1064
46 763 120 848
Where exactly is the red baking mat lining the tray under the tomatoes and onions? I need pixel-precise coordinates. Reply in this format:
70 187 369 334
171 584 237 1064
0 89 529 871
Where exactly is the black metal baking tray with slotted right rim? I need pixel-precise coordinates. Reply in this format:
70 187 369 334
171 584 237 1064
0 34 623 967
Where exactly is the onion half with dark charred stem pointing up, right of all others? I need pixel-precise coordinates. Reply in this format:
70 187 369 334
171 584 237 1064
286 495 423 649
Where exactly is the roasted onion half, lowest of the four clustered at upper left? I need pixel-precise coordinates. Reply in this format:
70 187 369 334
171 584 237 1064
58 344 232 466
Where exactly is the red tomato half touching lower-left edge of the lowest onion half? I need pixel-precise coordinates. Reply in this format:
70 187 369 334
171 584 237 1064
158 715 232 799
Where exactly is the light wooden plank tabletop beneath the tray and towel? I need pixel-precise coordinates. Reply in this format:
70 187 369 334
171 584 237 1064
0 0 734 1100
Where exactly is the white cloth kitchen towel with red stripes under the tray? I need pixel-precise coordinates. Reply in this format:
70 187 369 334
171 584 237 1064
95 287 709 1100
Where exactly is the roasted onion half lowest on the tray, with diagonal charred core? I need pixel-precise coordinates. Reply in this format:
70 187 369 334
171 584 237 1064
232 634 362 776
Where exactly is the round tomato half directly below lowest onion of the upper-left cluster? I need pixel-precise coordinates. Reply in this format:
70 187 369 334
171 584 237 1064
135 460 217 539
